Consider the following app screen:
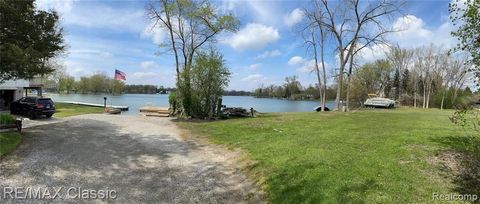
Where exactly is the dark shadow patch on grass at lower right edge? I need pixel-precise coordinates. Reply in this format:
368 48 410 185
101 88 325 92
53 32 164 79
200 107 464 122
433 136 480 199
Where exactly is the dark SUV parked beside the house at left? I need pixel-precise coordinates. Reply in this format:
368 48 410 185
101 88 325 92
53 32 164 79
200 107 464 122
10 97 55 119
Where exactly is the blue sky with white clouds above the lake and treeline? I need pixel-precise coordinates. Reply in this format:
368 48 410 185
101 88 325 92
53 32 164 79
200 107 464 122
36 0 456 91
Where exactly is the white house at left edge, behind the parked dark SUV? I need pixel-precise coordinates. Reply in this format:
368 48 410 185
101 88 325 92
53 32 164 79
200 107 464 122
0 79 43 111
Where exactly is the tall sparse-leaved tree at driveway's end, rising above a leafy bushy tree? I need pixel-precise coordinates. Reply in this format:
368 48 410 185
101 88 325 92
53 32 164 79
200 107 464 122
147 0 238 115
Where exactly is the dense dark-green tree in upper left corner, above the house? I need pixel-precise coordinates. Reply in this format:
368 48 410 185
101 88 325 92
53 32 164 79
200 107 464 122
0 0 65 82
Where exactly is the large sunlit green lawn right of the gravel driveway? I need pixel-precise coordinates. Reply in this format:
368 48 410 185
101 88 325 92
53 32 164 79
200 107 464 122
179 109 480 203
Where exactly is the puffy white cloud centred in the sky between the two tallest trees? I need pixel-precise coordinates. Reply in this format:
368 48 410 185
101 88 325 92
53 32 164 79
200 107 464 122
223 23 280 50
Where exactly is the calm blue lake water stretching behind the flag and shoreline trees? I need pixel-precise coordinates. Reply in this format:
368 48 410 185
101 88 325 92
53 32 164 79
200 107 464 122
45 93 333 114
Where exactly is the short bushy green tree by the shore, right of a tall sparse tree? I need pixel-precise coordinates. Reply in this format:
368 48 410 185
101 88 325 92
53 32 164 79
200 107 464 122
189 50 230 118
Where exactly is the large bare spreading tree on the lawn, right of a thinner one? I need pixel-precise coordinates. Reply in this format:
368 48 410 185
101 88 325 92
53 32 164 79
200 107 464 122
318 0 401 110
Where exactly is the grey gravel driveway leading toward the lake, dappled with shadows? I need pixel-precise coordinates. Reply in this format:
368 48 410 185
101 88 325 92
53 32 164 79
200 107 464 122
0 114 262 203
